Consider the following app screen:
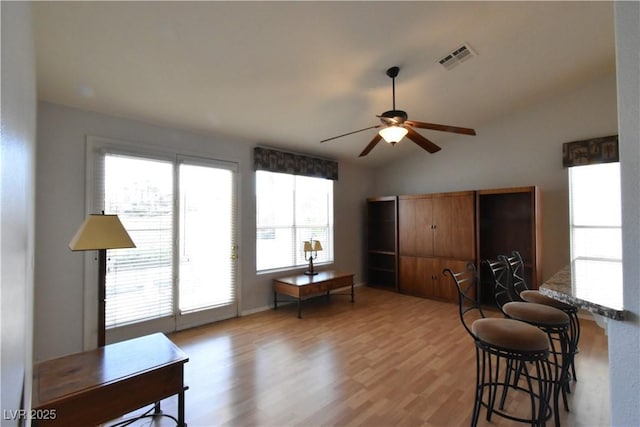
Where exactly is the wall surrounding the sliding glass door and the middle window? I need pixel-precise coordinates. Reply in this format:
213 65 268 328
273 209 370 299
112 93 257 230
34 103 372 360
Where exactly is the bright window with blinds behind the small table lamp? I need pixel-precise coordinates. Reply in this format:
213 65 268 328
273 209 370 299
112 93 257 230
256 170 333 272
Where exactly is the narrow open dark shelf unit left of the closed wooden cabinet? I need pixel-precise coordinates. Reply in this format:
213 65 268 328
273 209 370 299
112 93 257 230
367 196 398 290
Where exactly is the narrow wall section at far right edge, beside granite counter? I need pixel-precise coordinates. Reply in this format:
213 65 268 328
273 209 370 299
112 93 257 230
608 1 640 427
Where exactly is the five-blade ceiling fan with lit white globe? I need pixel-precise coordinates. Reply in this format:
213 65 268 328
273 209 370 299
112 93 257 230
320 67 476 157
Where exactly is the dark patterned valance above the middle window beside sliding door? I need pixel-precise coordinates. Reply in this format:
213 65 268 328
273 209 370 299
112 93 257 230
253 147 338 181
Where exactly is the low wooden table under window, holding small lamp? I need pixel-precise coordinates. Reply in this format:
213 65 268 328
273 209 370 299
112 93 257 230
273 271 354 319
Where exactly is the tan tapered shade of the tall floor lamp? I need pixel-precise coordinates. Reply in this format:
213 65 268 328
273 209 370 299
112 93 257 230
69 214 136 251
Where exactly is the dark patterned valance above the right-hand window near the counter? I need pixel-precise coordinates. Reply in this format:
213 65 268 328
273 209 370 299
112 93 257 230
562 135 620 168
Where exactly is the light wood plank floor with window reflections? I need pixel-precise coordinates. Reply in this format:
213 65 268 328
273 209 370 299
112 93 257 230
116 287 609 427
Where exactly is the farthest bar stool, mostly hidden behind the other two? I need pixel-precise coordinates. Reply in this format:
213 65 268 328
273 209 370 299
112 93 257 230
498 251 580 381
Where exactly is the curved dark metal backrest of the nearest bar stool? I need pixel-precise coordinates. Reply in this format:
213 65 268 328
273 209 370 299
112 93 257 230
442 262 484 339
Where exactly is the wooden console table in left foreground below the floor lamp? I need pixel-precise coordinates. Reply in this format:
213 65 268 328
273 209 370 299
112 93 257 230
32 334 189 426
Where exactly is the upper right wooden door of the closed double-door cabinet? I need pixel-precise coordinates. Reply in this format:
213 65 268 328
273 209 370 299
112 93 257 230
433 193 475 260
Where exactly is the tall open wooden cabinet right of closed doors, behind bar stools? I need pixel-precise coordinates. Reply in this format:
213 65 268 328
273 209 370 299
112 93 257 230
476 186 542 304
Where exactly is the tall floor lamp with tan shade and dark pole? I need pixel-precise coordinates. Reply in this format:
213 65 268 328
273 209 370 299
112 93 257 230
69 213 136 347
